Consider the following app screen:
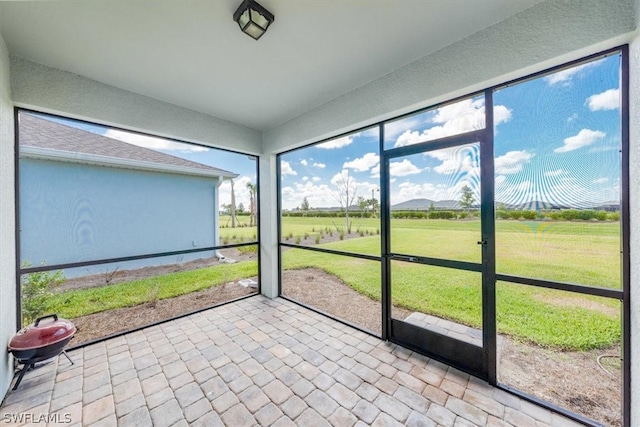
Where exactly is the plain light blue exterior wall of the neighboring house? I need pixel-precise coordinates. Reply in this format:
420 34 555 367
19 158 218 276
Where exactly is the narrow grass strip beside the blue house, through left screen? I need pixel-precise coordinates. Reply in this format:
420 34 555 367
45 261 258 319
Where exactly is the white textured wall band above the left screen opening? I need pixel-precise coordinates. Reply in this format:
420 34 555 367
10 56 262 154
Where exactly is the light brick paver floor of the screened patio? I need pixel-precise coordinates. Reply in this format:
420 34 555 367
0 296 578 427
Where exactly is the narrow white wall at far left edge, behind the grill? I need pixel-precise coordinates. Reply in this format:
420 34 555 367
0 31 16 401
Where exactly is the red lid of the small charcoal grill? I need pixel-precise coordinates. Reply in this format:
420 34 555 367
9 314 76 351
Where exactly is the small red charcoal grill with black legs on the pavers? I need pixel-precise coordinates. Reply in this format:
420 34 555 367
9 314 76 390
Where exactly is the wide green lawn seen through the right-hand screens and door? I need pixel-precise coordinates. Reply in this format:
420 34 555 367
283 218 620 350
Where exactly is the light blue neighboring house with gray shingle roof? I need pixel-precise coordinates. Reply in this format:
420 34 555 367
19 113 237 276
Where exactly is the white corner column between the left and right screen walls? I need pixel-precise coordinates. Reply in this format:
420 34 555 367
259 153 280 298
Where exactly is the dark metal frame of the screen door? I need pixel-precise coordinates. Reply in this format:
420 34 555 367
380 89 497 384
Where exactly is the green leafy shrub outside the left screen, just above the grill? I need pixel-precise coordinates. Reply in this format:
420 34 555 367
21 261 66 326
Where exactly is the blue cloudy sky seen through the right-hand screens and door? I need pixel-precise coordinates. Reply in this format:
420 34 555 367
281 55 620 209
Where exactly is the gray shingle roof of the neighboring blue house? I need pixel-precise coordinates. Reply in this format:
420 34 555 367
19 112 237 177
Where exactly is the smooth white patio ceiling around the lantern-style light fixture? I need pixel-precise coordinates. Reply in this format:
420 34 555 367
0 0 540 131
